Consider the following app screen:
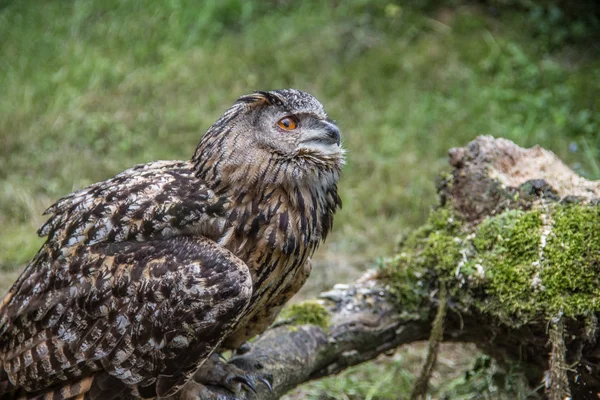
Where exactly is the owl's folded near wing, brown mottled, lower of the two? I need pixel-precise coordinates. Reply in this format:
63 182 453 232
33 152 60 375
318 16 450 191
0 236 252 398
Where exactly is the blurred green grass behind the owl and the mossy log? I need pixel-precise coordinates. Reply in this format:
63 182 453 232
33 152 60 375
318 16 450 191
0 0 600 399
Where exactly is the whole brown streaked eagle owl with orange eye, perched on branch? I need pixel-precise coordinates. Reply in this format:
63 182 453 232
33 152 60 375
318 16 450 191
0 89 344 399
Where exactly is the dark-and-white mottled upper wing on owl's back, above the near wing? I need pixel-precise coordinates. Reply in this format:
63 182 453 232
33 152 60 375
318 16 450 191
38 161 226 252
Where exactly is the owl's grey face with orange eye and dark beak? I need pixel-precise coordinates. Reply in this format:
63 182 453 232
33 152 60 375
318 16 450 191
238 89 343 159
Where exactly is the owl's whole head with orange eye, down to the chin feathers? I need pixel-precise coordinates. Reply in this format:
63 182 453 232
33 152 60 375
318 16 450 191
193 89 344 188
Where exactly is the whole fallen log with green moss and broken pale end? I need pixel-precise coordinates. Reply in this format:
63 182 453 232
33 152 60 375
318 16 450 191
195 137 600 399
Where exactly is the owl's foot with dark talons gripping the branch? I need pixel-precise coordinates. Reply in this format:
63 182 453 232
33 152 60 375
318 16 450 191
192 354 273 393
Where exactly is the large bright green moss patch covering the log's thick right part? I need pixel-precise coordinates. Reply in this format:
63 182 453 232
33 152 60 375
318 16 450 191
382 204 600 326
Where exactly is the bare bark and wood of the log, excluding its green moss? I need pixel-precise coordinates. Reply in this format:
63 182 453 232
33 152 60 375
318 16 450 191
197 136 600 400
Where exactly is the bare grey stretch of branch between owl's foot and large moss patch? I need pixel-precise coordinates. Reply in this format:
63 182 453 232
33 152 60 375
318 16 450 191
199 279 430 400
